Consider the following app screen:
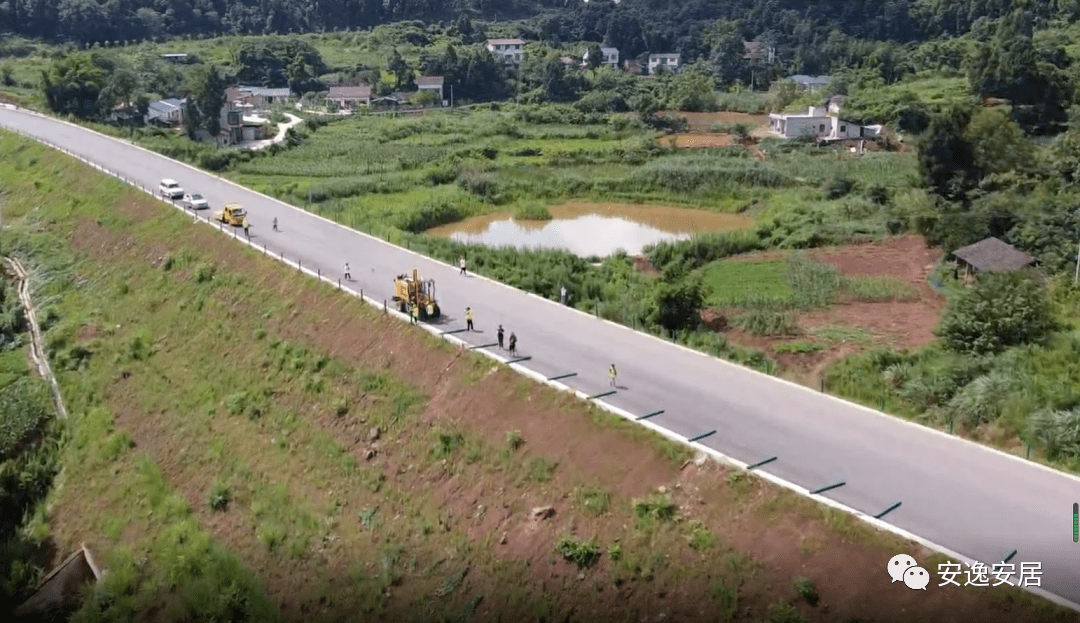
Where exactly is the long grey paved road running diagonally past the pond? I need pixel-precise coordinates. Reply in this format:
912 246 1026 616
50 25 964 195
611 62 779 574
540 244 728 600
0 107 1080 602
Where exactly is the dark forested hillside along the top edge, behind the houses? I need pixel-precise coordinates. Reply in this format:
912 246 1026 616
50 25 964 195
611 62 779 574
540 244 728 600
6 0 1080 50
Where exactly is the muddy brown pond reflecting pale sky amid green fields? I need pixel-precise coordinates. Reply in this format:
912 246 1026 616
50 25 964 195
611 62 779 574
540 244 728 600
427 203 754 257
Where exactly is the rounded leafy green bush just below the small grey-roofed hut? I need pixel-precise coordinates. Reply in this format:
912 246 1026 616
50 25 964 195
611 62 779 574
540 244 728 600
936 271 1055 354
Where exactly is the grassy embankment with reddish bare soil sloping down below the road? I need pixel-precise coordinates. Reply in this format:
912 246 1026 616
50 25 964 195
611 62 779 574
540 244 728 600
0 130 1075 622
